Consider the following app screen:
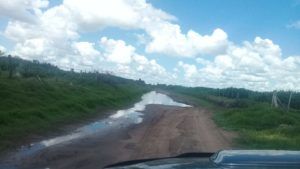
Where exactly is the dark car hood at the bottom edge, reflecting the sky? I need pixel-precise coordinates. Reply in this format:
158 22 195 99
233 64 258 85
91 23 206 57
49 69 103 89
105 150 300 169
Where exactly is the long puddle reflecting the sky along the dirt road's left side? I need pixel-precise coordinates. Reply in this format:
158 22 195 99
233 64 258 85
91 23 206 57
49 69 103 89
14 91 190 156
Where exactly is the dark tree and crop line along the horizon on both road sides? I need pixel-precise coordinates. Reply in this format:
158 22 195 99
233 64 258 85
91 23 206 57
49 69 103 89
0 51 300 109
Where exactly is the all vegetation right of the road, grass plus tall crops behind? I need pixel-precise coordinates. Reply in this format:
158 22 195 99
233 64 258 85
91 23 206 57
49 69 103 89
159 85 300 150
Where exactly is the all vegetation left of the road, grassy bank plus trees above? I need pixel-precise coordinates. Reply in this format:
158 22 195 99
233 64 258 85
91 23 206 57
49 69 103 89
0 57 149 151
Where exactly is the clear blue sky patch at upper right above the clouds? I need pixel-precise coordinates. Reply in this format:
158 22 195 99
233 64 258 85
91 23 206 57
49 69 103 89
149 0 300 55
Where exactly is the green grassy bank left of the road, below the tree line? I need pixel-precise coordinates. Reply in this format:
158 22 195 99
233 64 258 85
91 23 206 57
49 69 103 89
0 72 146 151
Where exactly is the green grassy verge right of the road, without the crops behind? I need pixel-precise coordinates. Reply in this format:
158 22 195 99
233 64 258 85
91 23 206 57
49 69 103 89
164 88 300 150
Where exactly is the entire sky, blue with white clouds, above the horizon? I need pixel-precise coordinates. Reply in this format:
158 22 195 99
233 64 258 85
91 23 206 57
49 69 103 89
0 0 300 91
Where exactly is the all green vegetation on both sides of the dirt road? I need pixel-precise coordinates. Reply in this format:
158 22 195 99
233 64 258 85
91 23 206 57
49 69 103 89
0 53 300 151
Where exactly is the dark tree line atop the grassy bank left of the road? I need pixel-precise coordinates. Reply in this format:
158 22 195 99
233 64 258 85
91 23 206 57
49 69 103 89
0 53 145 85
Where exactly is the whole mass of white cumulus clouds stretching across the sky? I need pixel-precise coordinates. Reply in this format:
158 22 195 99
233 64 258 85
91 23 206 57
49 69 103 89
0 0 300 90
